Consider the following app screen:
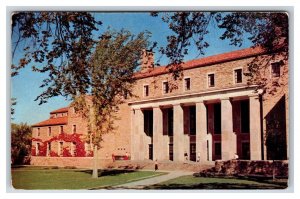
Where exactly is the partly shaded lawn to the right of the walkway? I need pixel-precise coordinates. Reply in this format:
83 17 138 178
144 176 287 189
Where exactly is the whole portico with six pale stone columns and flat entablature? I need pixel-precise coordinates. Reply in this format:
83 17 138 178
129 87 262 163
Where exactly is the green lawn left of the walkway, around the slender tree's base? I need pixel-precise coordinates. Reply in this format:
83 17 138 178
12 167 165 190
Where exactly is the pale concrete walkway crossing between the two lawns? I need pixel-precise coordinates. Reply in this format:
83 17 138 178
113 170 194 189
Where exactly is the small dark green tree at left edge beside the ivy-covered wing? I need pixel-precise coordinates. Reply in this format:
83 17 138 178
11 123 32 164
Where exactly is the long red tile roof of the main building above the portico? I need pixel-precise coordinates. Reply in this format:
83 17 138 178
134 47 266 79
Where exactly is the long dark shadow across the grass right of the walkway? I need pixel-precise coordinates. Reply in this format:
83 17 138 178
143 183 287 190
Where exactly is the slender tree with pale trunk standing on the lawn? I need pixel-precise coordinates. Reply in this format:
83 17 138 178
74 30 149 178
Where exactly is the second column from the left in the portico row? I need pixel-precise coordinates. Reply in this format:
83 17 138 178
153 107 165 161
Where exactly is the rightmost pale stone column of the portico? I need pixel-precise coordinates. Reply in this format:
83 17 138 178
249 95 262 160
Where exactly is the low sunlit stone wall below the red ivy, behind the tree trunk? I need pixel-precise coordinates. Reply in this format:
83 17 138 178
30 156 112 168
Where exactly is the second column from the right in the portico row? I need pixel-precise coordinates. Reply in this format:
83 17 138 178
221 98 237 160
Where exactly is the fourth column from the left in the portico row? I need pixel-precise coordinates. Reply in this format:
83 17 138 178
196 101 207 162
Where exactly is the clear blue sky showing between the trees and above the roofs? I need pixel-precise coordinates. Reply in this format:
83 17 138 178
11 12 250 124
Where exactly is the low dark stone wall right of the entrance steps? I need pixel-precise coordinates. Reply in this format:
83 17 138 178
214 160 289 177
